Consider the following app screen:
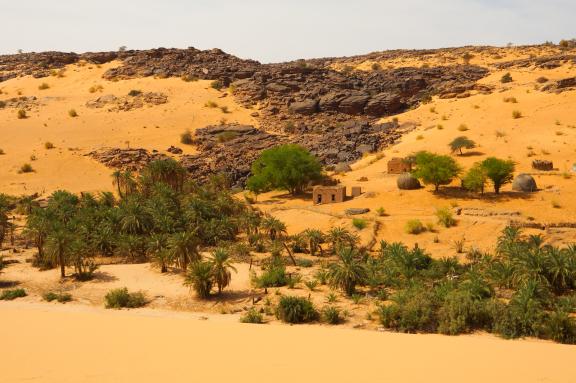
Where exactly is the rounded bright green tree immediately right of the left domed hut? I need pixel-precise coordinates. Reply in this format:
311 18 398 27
413 152 461 191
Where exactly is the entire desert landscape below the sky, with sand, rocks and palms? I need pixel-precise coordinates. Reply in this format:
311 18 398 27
0 40 576 382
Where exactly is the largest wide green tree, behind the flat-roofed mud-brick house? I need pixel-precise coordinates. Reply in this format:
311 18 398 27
247 145 322 195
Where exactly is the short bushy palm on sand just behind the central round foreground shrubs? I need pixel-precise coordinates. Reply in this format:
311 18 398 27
328 247 368 296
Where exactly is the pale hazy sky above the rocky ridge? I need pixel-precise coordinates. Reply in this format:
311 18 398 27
0 0 576 62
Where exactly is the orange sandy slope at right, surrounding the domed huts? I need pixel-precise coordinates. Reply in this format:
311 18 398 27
258 60 576 256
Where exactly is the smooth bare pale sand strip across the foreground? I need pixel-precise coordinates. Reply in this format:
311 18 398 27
0 302 576 383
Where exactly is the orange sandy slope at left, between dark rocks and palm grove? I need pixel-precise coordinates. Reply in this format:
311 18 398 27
0 63 255 194
